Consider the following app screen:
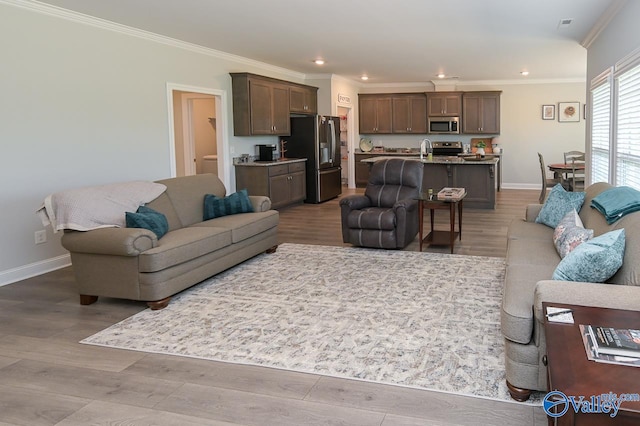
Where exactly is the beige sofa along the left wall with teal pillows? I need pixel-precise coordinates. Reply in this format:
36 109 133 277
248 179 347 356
62 174 279 309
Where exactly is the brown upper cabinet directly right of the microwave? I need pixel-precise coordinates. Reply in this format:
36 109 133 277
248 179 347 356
462 92 502 134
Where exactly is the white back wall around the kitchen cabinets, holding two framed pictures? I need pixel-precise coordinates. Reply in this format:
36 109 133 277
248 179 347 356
362 82 585 189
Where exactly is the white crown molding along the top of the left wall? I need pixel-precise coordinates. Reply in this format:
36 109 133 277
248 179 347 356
0 0 305 80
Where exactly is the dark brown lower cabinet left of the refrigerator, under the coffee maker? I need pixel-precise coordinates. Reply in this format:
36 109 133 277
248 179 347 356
236 162 307 209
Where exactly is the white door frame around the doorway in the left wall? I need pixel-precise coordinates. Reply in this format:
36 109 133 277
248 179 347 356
167 83 231 190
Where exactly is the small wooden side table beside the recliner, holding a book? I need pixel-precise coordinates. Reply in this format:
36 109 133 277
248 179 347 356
416 192 467 254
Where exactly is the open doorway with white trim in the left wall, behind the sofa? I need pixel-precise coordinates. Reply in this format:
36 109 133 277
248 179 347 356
167 84 231 188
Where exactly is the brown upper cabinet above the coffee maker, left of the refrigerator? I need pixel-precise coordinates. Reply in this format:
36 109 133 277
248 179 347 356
231 73 291 136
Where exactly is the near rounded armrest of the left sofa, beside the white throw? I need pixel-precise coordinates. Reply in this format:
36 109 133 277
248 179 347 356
61 228 158 256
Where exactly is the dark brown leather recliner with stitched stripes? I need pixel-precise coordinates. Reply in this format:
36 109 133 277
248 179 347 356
340 158 423 249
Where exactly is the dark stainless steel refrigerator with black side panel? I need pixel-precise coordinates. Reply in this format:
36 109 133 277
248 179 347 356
285 115 342 203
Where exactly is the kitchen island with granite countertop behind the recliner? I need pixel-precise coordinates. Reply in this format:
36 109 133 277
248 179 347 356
361 154 500 209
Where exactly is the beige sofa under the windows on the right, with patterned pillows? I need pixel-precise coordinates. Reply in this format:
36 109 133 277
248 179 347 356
501 183 640 401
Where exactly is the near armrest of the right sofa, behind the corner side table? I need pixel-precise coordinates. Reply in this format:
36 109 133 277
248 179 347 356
533 280 640 322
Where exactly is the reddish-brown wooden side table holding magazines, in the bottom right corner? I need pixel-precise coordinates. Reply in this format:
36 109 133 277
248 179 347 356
542 303 640 426
